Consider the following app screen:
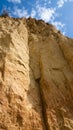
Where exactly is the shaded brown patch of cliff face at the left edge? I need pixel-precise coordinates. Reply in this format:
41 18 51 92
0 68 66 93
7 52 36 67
0 33 11 80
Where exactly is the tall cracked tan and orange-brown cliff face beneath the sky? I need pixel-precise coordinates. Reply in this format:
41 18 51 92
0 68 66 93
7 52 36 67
0 18 73 130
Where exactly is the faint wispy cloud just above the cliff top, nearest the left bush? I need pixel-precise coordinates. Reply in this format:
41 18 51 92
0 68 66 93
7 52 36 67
12 7 29 18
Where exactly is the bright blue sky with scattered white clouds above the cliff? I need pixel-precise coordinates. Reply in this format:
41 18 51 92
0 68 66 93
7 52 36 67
0 0 73 38
